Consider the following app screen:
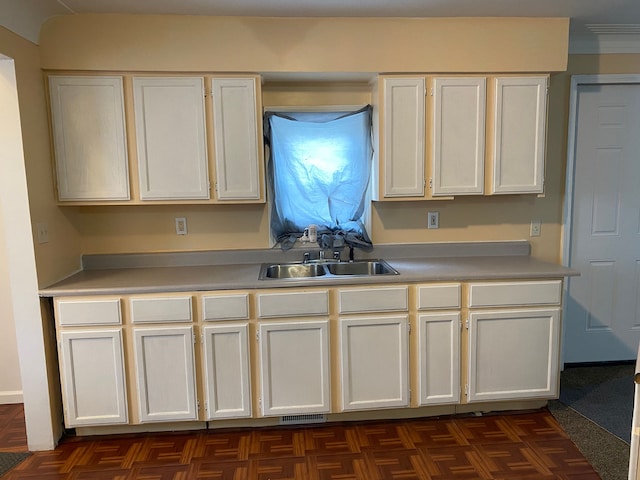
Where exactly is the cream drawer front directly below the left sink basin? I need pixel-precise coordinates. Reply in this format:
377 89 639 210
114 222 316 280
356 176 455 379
257 290 329 318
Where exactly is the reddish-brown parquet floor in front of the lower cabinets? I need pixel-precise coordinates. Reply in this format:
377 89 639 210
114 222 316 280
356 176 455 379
0 405 600 480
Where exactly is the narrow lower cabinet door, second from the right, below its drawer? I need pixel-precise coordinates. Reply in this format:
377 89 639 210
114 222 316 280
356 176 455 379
418 313 460 405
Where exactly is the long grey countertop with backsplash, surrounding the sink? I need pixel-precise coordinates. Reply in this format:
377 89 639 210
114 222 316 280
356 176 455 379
40 242 579 297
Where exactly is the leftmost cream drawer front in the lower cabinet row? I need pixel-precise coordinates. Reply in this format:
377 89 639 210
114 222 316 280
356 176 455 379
56 298 122 326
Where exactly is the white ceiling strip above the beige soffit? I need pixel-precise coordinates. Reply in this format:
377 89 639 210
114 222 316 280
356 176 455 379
0 0 640 50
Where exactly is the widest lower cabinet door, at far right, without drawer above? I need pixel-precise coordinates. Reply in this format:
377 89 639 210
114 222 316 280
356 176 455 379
468 308 560 402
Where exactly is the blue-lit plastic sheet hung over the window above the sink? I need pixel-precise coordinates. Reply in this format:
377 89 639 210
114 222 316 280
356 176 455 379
265 106 373 248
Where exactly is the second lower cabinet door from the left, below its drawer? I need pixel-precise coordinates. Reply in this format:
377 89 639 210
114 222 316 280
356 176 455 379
133 326 198 423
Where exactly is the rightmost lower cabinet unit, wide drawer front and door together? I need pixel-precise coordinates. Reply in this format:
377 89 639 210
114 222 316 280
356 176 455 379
467 280 562 402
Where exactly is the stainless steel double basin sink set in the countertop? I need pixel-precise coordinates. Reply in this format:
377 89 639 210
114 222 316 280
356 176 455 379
259 259 398 280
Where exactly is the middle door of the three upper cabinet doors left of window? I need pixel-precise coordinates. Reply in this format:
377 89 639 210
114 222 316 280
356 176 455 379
133 77 209 200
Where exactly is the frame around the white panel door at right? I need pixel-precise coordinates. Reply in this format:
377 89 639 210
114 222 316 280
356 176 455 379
560 74 640 369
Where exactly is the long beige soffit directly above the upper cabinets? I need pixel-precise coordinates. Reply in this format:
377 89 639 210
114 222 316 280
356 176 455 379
40 15 569 72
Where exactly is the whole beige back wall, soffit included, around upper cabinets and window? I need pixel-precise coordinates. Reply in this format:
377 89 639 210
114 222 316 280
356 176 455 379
33 15 568 261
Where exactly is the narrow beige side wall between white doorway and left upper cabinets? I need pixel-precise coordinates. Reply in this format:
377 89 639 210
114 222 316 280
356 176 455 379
0 27 81 286
